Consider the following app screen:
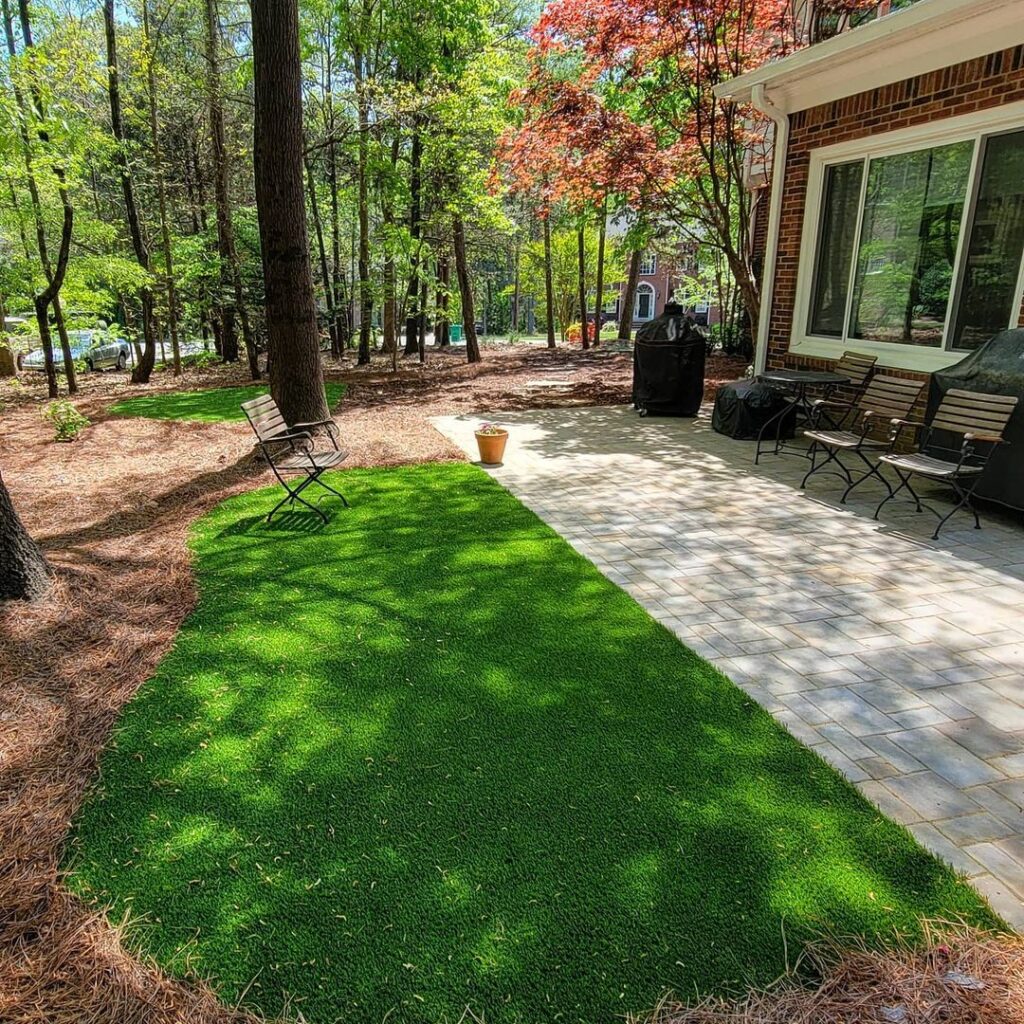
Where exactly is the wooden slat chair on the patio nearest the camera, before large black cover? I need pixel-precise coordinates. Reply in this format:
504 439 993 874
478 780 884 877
874 388 1019 540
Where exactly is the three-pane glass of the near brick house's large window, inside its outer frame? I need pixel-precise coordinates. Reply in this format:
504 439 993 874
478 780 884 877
804 130 1024 352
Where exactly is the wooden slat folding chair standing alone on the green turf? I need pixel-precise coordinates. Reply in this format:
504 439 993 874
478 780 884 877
242 394 348 522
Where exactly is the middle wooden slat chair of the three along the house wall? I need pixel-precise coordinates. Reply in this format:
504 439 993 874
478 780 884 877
800 375 925 504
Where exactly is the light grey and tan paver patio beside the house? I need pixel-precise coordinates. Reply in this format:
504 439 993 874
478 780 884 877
434 407 1024 928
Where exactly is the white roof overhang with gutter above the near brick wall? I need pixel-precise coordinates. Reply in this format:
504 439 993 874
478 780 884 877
715 0 1024 114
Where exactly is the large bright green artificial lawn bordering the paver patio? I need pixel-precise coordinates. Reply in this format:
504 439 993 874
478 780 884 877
70 465 994 1024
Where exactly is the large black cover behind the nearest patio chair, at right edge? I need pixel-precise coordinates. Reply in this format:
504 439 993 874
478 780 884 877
928 329 1024 509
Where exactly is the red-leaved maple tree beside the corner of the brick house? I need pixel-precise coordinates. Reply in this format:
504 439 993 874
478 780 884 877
496 0 879 319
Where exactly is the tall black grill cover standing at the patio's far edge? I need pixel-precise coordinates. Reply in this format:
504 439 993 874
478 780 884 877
633 303 708 416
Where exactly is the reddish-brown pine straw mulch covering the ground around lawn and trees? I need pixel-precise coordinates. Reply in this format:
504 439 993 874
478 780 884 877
0 346 1024 1024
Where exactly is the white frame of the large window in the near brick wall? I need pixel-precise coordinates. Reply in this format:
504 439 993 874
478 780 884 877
790 102 1024 372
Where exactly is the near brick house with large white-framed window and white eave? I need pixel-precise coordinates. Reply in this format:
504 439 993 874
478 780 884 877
717 0 1024 385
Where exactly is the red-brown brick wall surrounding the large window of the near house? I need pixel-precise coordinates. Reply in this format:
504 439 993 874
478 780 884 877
768 46 1024 391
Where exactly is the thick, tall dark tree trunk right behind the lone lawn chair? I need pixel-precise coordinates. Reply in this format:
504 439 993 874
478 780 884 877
252 0 330 424
